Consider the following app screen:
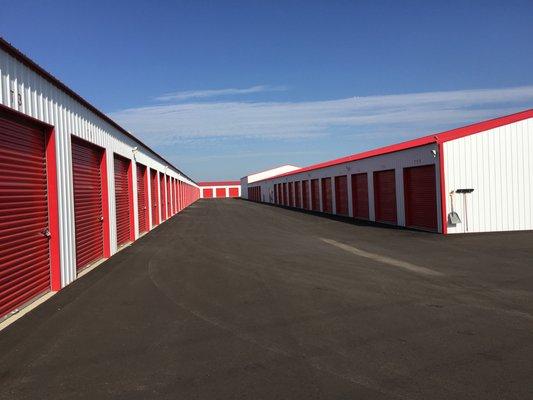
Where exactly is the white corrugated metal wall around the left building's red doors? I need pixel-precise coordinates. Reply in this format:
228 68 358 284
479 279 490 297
0 50 197 286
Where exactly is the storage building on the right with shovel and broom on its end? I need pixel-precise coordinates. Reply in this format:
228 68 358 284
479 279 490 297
247 109 533 233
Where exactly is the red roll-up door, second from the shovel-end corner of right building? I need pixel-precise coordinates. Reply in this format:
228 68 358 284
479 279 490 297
374 169 397 224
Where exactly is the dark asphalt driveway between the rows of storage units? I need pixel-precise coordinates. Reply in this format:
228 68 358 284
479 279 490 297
0 199 533 400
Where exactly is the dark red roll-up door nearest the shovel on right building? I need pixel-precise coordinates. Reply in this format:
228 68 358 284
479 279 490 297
403 164 438 231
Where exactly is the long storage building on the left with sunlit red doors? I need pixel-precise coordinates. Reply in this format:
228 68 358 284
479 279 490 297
0 39 199 319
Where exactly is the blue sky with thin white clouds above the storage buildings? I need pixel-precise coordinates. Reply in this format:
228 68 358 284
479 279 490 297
0 0 533 180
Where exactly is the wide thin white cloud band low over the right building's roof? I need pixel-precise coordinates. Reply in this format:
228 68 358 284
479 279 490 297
111 86 533 145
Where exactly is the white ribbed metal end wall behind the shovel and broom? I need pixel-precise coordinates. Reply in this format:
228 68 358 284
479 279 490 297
444 118 533 233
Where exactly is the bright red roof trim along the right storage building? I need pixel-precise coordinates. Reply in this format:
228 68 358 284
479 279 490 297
254 109 533 183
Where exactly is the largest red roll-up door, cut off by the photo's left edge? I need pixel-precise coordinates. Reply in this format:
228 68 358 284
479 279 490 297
0 114 50 317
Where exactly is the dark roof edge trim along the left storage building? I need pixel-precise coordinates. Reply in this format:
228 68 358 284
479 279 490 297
0 37 194 182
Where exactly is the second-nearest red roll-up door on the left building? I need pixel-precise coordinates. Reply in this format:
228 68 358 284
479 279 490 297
72 137 104 269
